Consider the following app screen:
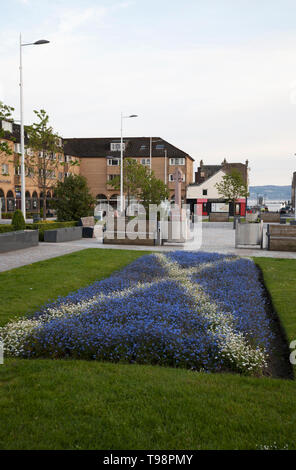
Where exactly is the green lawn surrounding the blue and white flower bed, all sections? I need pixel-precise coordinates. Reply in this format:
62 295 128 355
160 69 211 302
0 250 296 450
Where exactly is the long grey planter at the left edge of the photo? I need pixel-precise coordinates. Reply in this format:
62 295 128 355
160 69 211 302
0 230 39 253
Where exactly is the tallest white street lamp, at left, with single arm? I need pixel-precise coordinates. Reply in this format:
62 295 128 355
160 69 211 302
20 34 49 220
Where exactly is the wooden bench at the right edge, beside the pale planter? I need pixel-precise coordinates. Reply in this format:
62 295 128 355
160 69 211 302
267 224 296 251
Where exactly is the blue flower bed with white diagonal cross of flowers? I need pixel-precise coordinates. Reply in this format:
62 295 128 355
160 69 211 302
0 252 272 373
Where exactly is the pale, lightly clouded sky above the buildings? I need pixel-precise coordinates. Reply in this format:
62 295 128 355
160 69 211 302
0 0 296 185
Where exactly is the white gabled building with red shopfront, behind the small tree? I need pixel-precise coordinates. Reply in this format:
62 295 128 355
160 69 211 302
187 159 249 216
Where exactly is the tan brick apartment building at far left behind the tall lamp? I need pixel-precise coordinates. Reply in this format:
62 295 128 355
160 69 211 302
0 120 80 213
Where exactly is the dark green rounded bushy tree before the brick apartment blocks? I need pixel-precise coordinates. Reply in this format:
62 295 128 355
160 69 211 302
52 175 95 221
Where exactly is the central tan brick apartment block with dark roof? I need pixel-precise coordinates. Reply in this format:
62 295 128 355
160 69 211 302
64 137 194 204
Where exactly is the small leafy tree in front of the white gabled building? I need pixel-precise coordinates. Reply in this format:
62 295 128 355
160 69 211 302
215 169 249 219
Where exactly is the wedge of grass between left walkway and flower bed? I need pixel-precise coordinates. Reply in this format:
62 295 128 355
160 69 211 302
0 248 149 326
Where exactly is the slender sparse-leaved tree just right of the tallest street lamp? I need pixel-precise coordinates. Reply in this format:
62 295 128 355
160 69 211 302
26 109 77 220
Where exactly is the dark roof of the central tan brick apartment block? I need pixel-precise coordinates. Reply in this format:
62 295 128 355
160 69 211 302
63 137 193 161
